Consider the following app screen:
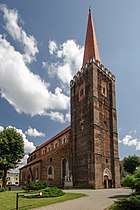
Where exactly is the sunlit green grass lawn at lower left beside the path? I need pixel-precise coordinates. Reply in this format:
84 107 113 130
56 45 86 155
0 191 86 210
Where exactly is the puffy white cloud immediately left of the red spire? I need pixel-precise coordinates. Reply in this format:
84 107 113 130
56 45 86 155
42 40 84 85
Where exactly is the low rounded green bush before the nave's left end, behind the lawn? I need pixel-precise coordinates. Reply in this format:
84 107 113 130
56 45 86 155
22 181 48 192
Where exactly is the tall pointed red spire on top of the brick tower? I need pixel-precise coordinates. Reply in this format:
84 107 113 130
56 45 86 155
83 9 101 66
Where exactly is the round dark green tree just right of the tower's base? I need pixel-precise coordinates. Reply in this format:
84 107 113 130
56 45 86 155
123 155 140 174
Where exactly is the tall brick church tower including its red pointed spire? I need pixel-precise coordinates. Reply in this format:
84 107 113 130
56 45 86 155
70 10 120 189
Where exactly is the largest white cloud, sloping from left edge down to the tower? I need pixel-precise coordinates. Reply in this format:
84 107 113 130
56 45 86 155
0 37 69 120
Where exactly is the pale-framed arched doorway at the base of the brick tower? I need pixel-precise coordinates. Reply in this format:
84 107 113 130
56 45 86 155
103 168 112 189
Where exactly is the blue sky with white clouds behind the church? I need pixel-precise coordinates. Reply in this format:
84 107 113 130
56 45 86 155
0 0 140 168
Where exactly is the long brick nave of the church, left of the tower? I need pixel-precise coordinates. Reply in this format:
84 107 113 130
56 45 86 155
20 128 70 185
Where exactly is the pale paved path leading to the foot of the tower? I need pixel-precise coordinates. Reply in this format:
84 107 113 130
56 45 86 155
33 188 132 210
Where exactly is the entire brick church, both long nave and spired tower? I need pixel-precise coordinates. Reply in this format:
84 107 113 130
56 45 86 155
20 10 120 189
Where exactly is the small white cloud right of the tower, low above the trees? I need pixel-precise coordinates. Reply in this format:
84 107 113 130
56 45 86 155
119 135 140 150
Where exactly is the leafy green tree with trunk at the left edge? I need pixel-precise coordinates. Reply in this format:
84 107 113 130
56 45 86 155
0 127 24 187
